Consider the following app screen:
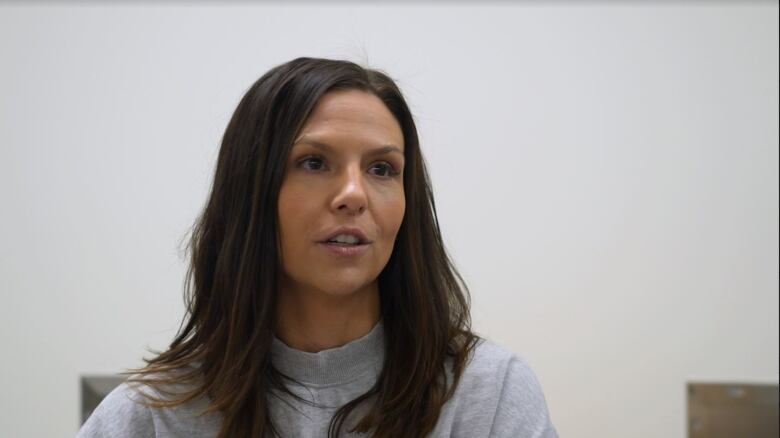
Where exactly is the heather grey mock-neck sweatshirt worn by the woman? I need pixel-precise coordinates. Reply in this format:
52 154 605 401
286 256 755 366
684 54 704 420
77 321 558 438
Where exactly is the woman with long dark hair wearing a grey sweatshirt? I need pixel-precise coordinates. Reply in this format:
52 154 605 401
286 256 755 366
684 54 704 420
79 58 557 438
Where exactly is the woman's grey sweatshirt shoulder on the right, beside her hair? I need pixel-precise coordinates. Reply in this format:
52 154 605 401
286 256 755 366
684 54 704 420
442 339 557 438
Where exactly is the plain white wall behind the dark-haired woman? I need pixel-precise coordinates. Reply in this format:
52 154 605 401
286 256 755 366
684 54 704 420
0 2 778 438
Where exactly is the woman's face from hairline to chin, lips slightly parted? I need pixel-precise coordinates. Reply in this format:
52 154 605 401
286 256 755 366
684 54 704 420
279 90 406 302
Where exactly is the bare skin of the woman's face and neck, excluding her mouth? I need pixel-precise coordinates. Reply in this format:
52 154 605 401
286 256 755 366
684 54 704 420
276 90 406 352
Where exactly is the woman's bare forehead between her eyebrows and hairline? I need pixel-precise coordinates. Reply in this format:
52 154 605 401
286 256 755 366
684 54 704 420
296 90 404 148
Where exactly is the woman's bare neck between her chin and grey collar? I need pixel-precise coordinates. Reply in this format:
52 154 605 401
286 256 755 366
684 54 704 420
276 282 381 353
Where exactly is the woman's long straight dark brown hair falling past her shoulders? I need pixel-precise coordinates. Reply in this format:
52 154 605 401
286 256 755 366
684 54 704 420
123 58 479 437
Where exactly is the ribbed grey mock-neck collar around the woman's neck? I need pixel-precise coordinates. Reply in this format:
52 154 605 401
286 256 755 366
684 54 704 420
271 319 385 385
